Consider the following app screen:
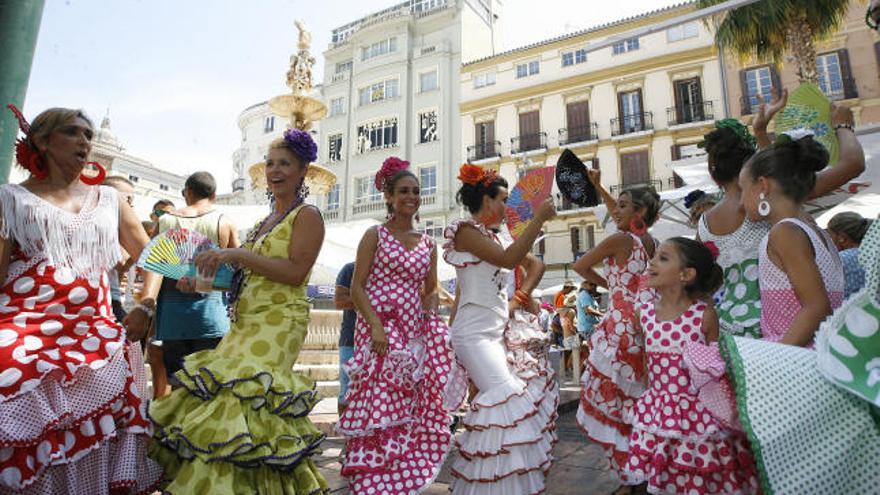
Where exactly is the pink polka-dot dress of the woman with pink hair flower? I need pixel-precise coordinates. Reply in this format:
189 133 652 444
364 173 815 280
336 226 453 494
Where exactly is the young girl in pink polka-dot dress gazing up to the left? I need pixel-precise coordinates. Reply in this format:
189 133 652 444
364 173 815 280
624 237 757 494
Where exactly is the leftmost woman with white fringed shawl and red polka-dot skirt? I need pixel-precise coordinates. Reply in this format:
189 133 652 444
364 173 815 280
0 108 162 495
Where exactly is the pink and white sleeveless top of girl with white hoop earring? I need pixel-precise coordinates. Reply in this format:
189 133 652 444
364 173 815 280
758 218 844 342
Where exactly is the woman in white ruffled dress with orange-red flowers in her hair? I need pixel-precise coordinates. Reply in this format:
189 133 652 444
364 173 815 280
444 165 556 495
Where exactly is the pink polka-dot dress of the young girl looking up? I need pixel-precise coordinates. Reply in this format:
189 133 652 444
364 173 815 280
625 303 758 494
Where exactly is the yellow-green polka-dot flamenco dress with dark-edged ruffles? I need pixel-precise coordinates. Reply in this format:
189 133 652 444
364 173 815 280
150 206 329 495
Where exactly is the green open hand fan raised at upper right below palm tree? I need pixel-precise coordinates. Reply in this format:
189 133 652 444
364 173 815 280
775 83 840 166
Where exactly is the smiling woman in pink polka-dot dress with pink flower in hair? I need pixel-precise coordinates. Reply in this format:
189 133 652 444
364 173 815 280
336 157 452 495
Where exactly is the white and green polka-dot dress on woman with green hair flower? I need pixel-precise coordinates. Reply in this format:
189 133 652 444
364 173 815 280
697 215 770 338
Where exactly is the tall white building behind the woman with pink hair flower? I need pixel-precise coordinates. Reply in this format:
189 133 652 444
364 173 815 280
318 0 501 232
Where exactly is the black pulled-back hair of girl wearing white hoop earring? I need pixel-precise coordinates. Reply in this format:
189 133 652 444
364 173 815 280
748 136 829 202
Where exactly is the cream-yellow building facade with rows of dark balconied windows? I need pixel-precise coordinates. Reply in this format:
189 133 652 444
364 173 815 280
460 2 726 286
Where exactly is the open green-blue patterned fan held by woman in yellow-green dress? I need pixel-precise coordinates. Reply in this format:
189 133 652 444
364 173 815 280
137 229 235 289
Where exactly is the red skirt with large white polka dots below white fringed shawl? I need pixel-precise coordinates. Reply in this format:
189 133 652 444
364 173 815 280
0 185 162 494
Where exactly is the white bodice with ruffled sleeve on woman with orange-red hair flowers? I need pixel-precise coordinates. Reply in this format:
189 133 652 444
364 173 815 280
443 219 512 317
